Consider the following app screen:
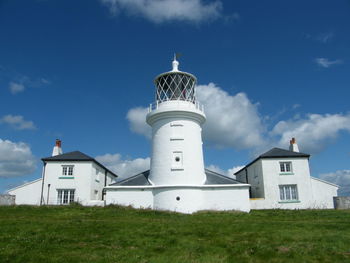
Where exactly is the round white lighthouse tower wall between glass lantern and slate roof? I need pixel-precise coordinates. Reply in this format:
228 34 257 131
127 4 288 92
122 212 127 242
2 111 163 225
147 101 206 185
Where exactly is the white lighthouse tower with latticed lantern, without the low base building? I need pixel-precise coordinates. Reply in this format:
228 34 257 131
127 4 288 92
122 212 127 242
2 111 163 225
146 57 206 185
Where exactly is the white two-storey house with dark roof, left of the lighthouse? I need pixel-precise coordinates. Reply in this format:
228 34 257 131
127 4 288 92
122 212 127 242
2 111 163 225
8 140 117 205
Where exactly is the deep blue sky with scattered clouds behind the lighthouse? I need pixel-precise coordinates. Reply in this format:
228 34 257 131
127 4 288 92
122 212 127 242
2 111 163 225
0 0 350 195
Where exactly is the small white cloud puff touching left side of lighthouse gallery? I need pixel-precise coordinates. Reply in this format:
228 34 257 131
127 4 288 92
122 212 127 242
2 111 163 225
126 107 152 138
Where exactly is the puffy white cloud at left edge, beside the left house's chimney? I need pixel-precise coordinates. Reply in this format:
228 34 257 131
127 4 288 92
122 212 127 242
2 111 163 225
0 139 36 177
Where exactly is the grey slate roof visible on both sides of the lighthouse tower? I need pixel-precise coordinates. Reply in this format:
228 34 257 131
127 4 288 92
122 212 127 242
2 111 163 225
110 169 240 186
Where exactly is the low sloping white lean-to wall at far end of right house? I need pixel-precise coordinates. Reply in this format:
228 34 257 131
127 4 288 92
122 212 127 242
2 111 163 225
311 177 338 209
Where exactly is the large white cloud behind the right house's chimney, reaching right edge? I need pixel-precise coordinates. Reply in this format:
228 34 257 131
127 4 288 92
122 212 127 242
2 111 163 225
271 114 350 153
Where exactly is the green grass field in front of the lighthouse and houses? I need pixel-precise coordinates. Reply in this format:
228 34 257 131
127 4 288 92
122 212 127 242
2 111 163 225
0 206 350 263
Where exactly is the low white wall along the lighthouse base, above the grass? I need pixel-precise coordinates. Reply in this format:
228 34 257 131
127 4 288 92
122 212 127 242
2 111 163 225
106 185 250 213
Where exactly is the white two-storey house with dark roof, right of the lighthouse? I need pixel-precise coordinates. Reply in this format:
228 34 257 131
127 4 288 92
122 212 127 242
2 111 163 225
235 138 339 209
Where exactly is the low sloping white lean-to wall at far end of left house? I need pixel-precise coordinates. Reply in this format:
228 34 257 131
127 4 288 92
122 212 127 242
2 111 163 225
8 178 42 205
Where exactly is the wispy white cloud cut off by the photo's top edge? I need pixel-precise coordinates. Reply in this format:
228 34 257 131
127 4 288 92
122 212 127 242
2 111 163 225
101 0 222 23
